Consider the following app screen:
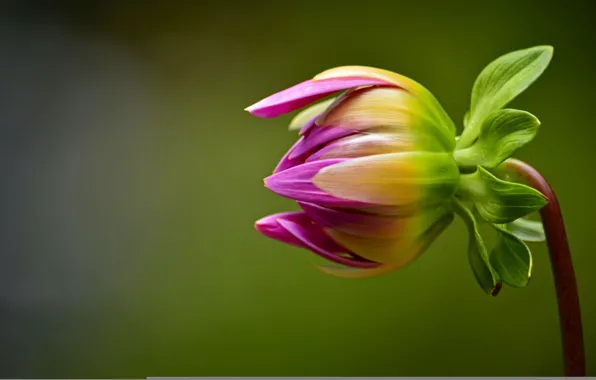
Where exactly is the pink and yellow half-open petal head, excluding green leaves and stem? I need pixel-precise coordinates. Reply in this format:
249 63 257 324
246 66 459 278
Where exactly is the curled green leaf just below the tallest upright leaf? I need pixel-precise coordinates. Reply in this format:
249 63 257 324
454 109 540 168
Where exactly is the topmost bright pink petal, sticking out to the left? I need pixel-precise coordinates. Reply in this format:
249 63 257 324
246 77 392 118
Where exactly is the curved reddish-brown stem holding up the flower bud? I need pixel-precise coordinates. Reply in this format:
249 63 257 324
505 159 586 376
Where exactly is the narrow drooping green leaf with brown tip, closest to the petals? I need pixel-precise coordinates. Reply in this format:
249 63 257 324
453 199 502 297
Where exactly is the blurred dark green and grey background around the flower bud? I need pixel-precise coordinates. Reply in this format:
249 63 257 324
0 0 596 378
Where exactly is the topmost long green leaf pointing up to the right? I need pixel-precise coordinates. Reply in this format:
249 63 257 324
458 46 553 148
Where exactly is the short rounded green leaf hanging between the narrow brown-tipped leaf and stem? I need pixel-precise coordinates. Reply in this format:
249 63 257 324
490 225 532 288
